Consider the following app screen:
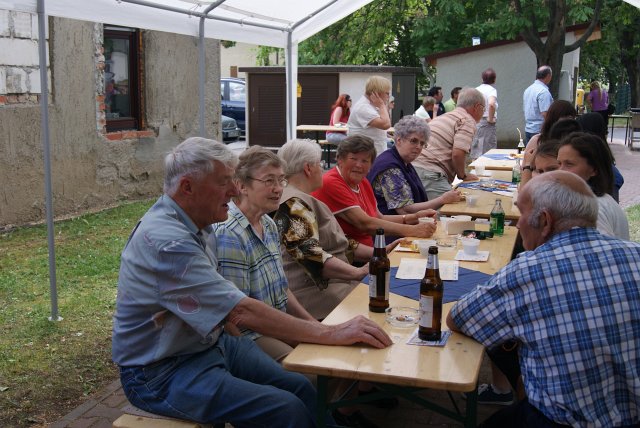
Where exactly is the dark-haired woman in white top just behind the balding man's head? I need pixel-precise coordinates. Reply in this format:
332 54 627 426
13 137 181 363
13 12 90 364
558 132 629 240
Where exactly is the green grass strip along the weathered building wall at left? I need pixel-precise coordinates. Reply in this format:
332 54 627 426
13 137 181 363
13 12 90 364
0 201 153 427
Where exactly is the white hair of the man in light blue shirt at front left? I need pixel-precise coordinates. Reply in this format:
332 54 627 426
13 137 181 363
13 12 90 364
163 137 238 196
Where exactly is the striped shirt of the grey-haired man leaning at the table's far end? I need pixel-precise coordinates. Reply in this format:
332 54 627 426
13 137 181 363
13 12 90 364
412 107 476 183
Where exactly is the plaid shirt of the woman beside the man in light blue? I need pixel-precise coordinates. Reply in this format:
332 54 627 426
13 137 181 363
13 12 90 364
208 202 288 339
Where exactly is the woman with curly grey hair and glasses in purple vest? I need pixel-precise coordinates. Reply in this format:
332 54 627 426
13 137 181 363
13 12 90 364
367 116 460 215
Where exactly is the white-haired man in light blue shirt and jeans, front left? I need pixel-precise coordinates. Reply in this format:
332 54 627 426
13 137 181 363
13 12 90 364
113 138 391 428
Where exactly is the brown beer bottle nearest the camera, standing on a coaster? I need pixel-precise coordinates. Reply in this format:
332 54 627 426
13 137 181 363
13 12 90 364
418 246 444 341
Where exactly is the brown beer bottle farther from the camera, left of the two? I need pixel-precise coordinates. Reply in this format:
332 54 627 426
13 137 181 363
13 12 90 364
369 229 391 312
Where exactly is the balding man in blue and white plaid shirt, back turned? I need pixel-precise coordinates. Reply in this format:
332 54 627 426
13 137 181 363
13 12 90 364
447 171 640 428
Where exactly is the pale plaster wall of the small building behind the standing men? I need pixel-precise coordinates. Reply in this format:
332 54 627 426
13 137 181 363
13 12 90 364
436 33 580 147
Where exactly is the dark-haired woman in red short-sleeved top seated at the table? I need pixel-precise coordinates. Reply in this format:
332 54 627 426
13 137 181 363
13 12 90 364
312 135 436 247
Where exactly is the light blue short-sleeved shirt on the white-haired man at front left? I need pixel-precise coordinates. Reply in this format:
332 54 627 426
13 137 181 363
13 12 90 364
112 195 246 366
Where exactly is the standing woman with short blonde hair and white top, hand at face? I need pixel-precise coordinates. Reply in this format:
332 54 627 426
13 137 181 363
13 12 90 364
347 76 391 156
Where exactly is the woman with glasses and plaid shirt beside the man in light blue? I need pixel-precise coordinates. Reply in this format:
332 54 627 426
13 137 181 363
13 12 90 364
208 146 316 361
